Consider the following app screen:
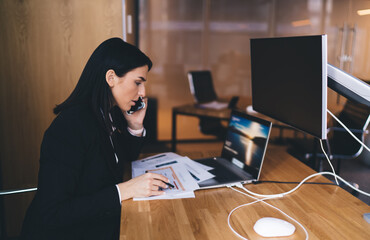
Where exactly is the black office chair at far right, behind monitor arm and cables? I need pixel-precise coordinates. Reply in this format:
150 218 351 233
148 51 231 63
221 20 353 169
291 100 370 175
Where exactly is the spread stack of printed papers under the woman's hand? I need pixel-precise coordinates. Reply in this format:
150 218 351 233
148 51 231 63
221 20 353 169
132 152 214 201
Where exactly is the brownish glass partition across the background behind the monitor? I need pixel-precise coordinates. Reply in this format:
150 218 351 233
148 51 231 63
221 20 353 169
139 0 370 140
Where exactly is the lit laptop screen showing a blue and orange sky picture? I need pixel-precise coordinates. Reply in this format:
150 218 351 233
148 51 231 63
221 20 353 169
221 111 271 179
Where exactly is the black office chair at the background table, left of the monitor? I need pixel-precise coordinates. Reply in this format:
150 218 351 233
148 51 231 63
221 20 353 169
188 70 239 140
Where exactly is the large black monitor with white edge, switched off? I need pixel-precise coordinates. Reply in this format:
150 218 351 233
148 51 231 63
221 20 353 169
250 35 327 139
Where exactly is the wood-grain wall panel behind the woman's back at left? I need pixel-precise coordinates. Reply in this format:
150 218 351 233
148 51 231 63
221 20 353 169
0 0 122 235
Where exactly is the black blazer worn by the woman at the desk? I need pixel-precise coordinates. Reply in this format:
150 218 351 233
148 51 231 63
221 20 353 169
21 105 143 240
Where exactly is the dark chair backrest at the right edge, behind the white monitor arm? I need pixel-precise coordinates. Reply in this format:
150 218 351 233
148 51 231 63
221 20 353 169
332 101 370 156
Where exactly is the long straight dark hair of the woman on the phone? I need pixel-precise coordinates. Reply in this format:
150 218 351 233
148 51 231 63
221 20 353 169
53 38 152 132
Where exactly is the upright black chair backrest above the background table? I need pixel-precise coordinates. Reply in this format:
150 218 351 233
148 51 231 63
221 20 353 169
188 71 217 103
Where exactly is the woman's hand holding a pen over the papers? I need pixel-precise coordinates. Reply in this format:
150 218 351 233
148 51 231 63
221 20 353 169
118 173 169 201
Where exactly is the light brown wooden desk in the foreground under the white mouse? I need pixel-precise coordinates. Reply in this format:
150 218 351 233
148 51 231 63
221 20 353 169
120 146 370 240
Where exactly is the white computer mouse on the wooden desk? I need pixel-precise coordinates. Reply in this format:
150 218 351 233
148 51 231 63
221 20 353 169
253 217 295 237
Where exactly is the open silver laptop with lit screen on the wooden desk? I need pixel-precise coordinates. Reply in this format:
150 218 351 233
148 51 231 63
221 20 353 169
196 110 272 189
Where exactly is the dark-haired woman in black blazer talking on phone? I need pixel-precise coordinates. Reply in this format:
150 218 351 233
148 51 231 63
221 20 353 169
22 38 168 239
